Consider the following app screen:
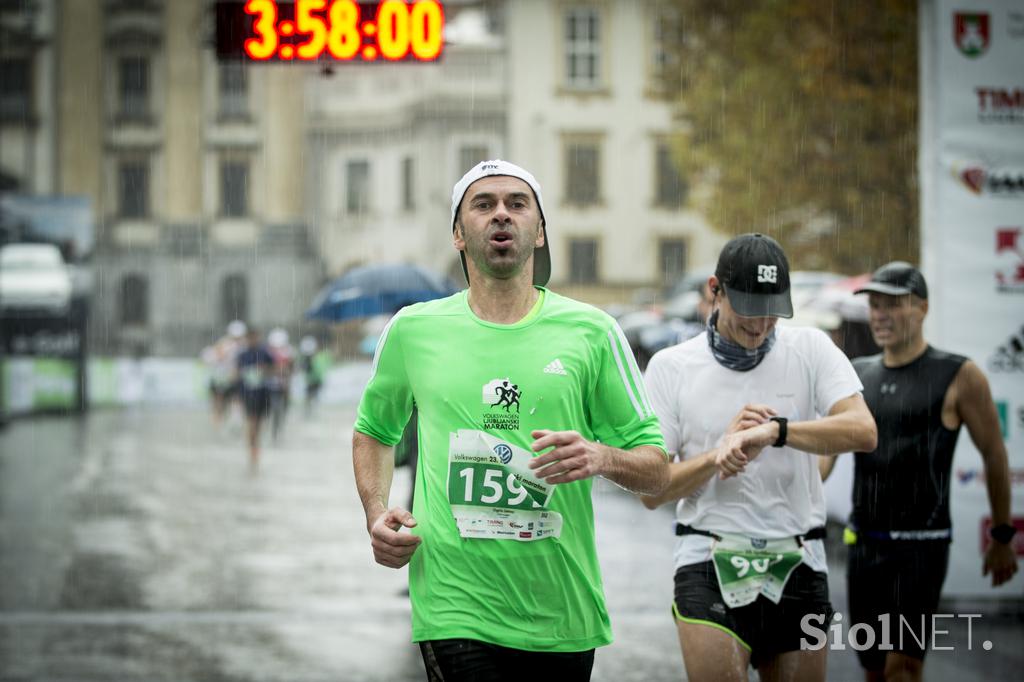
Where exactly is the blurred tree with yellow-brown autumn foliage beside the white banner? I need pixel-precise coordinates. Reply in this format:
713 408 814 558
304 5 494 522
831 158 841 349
665 0 919 273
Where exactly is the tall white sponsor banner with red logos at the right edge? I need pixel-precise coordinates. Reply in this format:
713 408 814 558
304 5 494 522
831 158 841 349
920 0 1024 598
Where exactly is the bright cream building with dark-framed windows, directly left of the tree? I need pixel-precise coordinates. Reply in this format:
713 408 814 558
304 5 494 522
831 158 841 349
506 0 725 300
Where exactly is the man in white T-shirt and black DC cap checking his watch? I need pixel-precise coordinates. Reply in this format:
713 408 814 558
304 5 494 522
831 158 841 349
642 235 877 682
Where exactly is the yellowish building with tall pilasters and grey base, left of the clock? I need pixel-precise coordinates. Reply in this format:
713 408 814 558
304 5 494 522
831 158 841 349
0 0 324 354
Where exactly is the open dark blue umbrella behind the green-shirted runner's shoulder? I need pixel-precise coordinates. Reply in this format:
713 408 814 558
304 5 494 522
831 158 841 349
306 264 456 322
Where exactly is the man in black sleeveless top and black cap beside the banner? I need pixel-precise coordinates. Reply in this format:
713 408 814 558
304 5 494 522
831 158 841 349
847 262 1017 682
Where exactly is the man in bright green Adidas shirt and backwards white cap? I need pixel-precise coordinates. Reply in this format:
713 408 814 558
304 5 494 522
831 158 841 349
352 161 668 680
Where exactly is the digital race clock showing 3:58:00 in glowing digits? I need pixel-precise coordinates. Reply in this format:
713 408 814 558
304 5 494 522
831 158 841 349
216 0 444 61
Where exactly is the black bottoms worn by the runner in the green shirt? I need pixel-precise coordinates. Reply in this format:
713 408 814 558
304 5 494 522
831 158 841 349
420 639 594 682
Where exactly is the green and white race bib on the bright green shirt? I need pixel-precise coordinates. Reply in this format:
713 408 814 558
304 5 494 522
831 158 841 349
447 429 562 542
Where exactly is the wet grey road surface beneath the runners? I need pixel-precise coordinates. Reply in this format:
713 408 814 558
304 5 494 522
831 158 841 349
0 395 1024 682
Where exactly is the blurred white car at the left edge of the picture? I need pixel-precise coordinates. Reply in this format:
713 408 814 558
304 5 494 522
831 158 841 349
0 244 72 315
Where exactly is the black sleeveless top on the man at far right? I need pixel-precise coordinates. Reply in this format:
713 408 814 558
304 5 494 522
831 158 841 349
851 346 967 530
